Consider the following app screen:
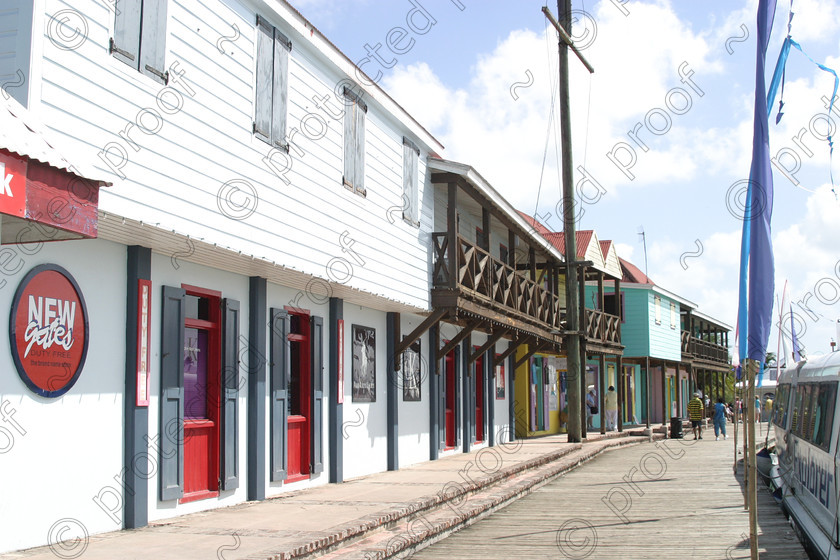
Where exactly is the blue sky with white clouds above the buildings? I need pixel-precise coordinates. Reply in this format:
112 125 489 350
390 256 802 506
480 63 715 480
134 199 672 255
291 0 840 355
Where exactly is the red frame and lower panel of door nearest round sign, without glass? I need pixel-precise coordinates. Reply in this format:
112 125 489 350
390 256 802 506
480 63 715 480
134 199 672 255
178 284 222 504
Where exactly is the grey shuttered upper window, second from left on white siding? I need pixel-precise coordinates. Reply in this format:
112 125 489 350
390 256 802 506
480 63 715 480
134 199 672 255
254 16 292 151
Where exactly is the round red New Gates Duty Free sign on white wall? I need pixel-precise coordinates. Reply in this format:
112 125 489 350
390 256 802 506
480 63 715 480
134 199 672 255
9 264 88 398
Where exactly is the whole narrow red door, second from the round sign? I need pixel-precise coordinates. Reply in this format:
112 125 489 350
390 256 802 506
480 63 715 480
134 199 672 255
286 309 312 482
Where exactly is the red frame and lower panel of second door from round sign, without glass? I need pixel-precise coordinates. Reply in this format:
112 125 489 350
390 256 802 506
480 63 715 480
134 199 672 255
285 306 312 483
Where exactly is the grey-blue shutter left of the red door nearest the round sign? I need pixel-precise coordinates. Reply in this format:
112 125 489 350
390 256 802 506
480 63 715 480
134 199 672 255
159 286 186 502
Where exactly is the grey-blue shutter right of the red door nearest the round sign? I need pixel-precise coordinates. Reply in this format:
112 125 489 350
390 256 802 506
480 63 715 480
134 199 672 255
220 298 239 490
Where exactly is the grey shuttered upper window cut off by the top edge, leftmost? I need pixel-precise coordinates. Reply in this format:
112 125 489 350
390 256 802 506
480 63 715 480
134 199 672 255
109 0 169 84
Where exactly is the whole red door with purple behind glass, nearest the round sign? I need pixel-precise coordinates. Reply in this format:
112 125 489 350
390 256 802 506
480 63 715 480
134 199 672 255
180 286 222 503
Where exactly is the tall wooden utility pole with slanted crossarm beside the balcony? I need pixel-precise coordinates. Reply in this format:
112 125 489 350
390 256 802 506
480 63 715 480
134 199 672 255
542 0 595 443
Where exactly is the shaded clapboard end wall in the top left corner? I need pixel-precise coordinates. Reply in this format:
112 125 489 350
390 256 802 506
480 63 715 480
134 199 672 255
0 0 32 106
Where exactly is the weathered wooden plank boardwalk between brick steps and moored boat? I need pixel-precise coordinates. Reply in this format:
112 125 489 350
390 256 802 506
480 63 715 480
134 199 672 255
414 425 807 560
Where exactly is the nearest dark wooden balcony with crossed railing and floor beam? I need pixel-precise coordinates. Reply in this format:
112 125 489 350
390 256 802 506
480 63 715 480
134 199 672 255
432 232 563 343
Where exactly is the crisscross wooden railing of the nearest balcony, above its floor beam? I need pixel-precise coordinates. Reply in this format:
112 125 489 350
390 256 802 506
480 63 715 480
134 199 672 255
432 232 563 330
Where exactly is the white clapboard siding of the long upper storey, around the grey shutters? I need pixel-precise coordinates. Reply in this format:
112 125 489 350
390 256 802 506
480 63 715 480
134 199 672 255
31 0 434 308
